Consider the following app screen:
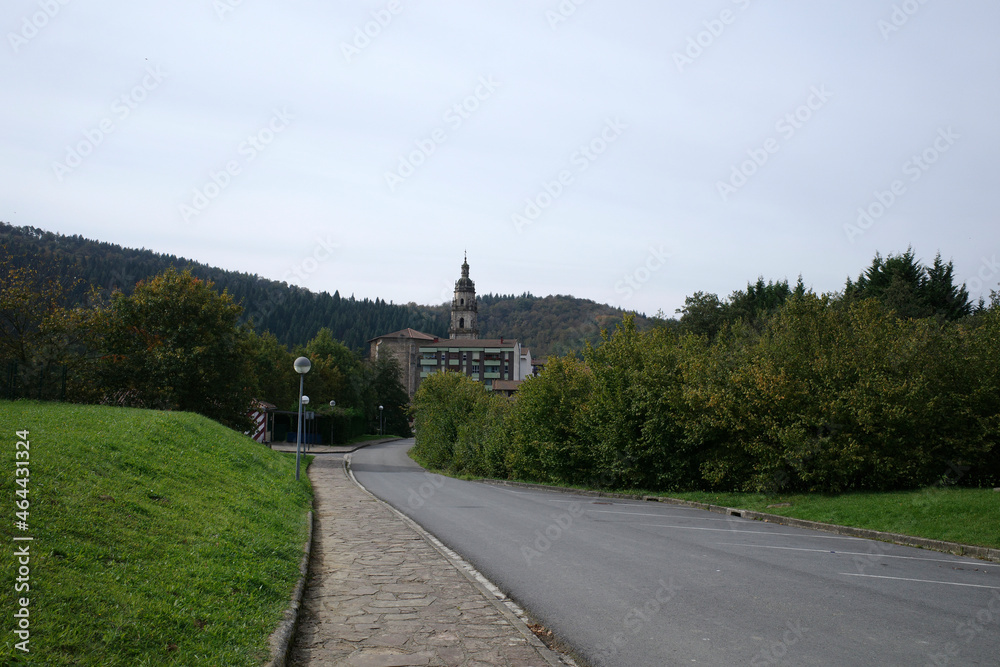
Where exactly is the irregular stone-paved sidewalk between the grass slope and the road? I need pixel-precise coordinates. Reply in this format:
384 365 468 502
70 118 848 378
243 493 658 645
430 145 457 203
289 456 571 667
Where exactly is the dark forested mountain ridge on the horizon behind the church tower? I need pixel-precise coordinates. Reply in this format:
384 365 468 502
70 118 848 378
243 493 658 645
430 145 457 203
0 222 640 357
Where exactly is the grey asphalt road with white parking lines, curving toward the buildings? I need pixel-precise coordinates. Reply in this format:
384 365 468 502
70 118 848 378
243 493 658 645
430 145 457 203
351 440 1000 667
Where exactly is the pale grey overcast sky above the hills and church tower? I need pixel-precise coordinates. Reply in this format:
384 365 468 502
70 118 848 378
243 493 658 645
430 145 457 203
0 0 1000 315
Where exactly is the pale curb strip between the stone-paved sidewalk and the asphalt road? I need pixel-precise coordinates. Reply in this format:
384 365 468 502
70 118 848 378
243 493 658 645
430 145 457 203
344 456 577 667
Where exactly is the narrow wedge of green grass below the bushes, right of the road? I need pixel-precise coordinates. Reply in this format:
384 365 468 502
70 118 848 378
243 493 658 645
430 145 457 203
663 487 1000 549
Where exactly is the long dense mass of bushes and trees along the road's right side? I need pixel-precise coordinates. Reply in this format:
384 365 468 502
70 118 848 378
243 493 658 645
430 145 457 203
414 251 1000 506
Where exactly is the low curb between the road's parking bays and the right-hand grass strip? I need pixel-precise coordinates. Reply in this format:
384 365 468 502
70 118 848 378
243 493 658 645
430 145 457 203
479 479 1000 563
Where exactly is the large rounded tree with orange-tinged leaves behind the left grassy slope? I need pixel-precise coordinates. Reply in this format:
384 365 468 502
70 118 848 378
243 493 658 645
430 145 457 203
93 268 257 429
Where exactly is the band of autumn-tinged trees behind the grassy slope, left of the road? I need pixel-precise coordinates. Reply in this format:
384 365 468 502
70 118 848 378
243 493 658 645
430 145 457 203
0 264 410 442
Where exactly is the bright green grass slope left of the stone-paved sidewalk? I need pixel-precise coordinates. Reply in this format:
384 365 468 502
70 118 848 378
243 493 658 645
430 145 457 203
0 402 312 667
